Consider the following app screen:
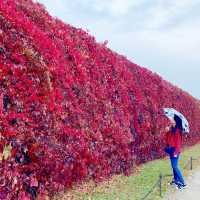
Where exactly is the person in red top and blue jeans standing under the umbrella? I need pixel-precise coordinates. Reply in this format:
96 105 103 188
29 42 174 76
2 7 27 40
165 115 186 189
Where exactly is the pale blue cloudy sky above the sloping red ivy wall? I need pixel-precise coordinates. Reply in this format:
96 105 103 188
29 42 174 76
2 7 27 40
38 0 200 99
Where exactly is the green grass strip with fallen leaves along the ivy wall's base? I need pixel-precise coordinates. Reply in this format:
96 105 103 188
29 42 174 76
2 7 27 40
54 144 200 200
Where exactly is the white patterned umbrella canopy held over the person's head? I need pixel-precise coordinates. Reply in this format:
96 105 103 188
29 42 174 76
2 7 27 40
163 108 190 133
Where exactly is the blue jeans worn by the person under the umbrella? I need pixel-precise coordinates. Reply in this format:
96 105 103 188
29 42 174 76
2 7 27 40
170 155 185 185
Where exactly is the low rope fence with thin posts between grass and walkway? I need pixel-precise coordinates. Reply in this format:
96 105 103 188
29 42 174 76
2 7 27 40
141 157 198 200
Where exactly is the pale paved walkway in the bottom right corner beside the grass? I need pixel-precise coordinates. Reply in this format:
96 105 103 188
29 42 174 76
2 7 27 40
165 169 200 200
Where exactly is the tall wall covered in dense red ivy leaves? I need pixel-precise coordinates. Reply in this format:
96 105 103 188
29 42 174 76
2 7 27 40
0 0 200 200
